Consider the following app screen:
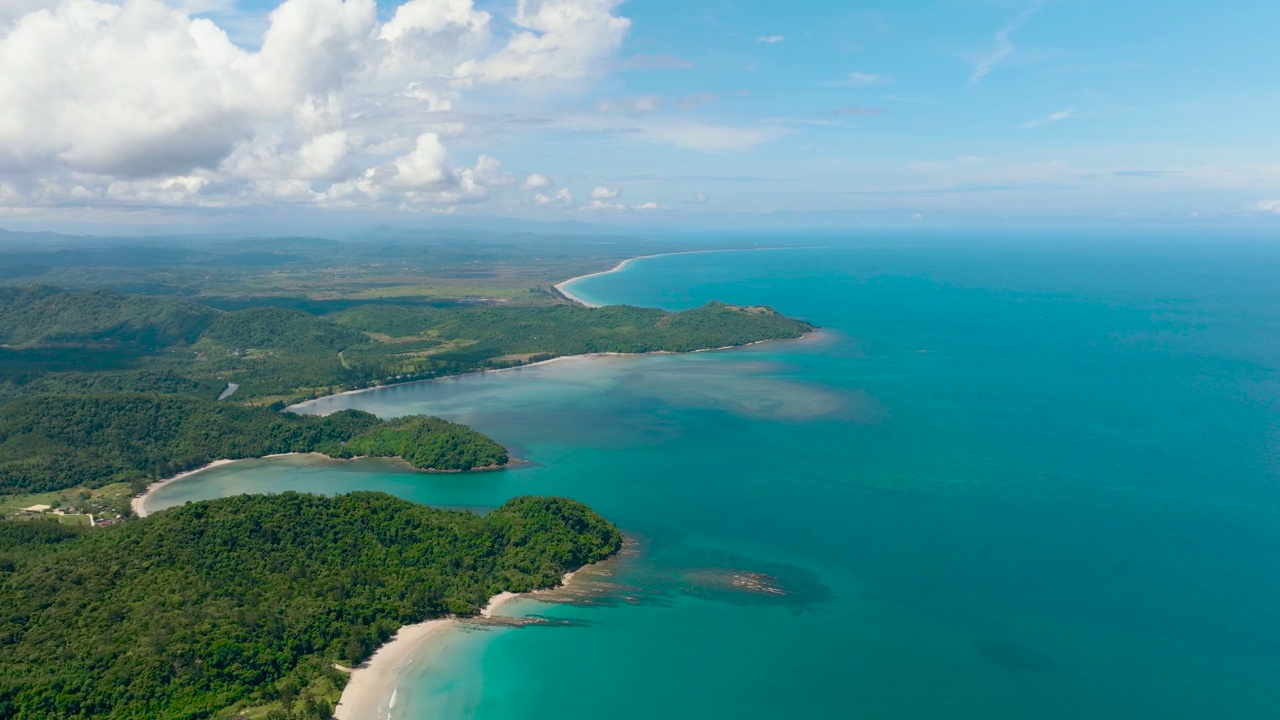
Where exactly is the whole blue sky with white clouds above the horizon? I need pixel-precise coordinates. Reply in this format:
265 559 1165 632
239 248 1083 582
0 0 1280 228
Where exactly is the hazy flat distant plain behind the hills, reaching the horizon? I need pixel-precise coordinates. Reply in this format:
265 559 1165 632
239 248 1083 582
0 229 681 299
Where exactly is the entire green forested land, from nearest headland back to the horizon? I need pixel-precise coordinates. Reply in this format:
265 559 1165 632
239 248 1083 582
0 242 813 720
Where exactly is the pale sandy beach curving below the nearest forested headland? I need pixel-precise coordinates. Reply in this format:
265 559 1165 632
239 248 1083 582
333 571 575 720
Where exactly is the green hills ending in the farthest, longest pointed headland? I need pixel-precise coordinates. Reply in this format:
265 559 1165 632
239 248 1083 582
0 287 812 406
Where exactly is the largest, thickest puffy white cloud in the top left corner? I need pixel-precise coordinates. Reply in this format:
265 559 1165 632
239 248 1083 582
0 0 375 177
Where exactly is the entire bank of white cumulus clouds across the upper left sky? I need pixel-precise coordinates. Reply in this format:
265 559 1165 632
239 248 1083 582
0 0 643 206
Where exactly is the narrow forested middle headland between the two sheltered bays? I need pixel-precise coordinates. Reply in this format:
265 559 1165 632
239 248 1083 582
0 395 507 493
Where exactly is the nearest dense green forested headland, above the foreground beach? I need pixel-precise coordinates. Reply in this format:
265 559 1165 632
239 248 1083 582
0 492 621 720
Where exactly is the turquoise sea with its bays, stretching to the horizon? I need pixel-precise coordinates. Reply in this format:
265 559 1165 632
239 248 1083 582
145 237 1280 720
